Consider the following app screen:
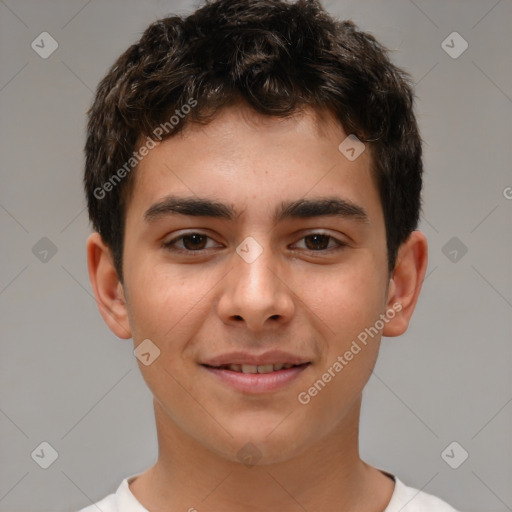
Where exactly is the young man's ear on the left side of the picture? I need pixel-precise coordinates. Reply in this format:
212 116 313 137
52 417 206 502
87 233 132 339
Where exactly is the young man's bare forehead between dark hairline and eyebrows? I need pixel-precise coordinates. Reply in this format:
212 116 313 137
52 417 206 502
128 105 379 223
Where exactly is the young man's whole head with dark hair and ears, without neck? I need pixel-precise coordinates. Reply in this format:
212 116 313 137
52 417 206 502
84 0 426 461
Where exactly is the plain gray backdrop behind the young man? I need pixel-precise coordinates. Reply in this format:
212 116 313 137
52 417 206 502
0 0 512 512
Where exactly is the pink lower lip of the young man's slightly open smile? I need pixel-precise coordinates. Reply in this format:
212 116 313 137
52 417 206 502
203 363 309 394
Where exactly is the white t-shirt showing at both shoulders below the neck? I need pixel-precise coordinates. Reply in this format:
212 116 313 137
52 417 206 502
79 472 457 512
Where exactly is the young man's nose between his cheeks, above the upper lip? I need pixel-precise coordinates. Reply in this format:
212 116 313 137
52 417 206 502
217 239 295 332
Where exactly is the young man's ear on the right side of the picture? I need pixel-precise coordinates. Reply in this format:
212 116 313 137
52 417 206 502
382 231 428 336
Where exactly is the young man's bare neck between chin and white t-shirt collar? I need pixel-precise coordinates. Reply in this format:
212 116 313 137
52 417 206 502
130 399 394 512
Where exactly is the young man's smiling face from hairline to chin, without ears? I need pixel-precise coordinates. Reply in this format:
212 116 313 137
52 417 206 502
115 106 396 462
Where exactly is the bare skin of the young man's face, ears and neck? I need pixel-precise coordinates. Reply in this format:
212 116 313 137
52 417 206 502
87 105 427 512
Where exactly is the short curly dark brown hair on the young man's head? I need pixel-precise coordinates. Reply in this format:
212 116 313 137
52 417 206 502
84 0 423 282
